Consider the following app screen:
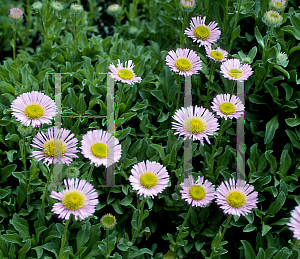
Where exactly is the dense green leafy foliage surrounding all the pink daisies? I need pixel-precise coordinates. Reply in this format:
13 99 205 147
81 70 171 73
0 0 300 259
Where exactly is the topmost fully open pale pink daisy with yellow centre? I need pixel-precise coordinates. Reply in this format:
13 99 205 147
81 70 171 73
184 16 221 47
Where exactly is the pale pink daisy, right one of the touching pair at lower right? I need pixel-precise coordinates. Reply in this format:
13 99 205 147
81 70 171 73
216 178 258 216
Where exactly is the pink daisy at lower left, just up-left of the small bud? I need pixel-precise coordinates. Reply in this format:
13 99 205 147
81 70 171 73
50 178 98 220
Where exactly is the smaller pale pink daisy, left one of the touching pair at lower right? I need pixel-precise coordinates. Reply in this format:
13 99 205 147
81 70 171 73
180 175 215 207
